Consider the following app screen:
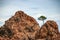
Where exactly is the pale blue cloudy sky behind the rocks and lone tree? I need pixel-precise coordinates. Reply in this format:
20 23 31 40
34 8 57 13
0 0 60 30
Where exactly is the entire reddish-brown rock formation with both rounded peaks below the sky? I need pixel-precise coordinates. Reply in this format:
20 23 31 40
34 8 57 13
0 11 60 40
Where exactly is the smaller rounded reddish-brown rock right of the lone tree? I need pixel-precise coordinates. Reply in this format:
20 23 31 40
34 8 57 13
40 20 59 40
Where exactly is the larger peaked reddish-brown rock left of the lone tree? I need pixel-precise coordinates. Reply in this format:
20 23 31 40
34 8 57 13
0 11 40 40
